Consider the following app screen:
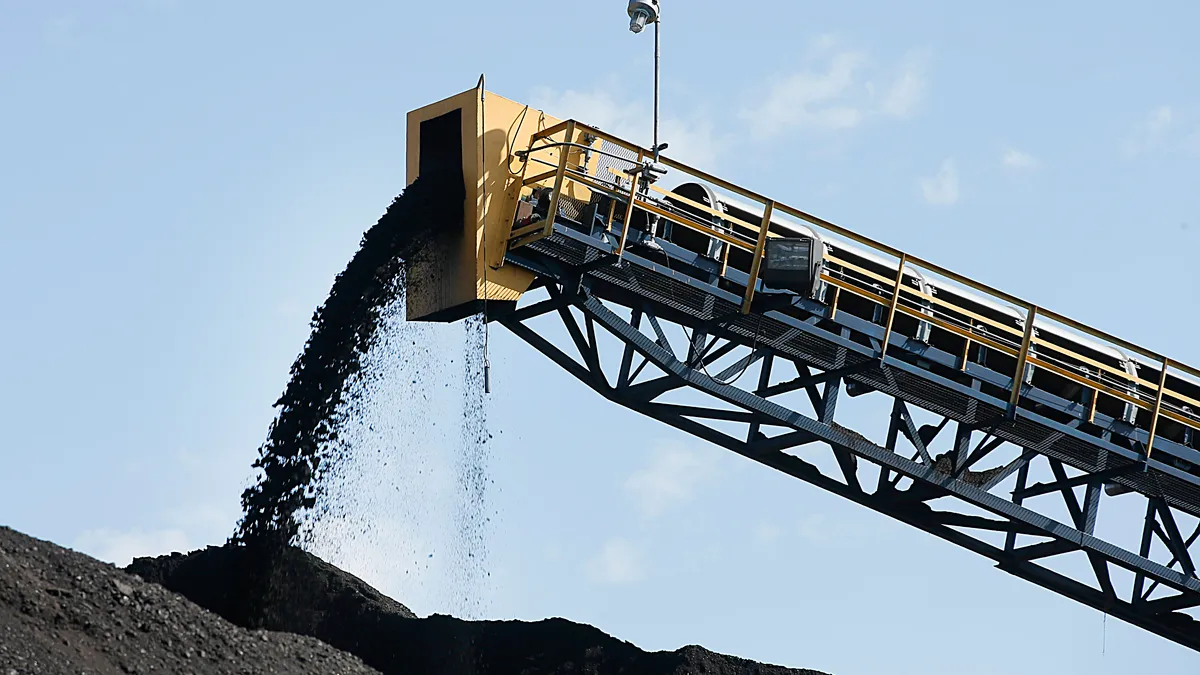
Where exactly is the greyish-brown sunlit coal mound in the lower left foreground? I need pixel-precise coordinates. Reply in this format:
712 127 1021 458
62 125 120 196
0 527 377 675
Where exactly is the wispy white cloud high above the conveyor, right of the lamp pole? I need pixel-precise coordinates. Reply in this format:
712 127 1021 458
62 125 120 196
739 36 928 139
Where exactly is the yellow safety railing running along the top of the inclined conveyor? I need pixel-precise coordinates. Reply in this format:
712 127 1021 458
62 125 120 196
508 120 1200 458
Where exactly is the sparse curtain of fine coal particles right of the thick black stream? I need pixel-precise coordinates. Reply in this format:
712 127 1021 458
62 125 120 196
300 303 496 619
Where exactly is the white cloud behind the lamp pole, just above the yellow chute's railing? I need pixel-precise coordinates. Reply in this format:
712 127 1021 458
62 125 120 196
530 79 724 166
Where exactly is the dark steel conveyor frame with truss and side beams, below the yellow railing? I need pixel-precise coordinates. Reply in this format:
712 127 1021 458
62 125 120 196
488 123 1200 651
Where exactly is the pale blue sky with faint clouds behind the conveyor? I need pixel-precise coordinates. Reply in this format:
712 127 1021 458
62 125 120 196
0 0 1200 675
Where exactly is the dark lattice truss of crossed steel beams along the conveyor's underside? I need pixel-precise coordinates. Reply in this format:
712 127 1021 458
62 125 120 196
499 276 1200 651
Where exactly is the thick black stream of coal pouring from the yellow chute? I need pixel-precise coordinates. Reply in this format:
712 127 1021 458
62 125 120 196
233 166 466 546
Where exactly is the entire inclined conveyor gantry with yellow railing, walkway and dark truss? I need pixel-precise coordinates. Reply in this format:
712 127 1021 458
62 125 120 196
491 123 1200 650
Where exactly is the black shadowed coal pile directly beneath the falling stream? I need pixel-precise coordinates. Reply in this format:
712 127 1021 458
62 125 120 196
127 545 821 675
